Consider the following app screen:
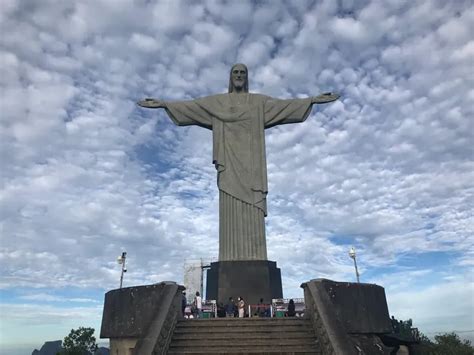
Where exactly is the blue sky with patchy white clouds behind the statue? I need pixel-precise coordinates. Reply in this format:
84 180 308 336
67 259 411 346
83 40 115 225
0 0 474 354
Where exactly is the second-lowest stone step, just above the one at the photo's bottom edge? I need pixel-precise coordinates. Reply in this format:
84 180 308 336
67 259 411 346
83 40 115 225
170 338 318 349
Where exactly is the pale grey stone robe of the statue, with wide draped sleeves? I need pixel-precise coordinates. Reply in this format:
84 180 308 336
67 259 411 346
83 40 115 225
166 93 312 261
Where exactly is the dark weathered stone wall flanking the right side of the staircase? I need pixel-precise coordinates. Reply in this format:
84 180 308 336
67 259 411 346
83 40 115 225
301 279 393 355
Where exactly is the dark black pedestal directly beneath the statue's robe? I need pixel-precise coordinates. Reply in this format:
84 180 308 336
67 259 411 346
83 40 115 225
206 260 283 305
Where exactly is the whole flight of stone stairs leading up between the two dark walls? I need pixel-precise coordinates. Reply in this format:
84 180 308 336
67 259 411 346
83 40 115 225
168 318 322 354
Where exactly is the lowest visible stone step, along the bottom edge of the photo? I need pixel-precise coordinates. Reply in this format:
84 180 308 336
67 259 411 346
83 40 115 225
168 343 322 355
